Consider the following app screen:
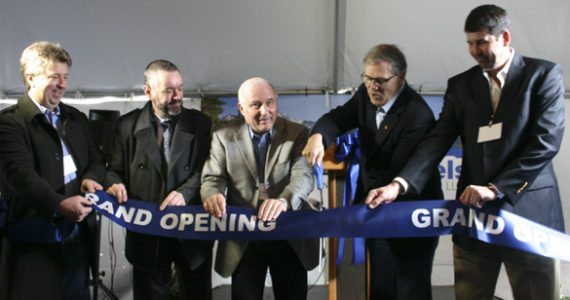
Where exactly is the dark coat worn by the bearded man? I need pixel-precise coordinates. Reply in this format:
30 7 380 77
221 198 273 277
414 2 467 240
105 101 213 268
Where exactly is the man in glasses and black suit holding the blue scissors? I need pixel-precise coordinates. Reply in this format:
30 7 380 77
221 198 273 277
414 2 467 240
303 45 443 299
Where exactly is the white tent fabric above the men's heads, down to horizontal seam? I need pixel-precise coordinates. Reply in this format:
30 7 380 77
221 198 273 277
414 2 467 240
0 0 570 95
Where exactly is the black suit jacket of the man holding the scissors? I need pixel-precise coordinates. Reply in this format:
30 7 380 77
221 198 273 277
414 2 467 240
312 83 443 256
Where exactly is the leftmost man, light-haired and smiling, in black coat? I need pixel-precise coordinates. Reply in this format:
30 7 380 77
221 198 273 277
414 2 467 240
0 42 105 299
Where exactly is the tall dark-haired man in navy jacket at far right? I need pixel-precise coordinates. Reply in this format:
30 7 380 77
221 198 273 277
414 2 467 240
366 5 565 300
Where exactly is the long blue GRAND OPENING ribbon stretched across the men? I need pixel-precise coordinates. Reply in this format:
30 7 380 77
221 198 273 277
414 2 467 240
86 191 570 261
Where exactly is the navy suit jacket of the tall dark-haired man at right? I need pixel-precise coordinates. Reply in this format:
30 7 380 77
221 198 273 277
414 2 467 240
401 53 565 247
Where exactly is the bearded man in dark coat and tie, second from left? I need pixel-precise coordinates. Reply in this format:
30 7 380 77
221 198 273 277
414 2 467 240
105 60 213 299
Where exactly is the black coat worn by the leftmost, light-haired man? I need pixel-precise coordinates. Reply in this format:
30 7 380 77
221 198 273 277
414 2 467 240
0 94 105 299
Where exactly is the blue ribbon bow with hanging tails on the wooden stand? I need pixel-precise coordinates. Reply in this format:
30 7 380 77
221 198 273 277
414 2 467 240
330 129 366 265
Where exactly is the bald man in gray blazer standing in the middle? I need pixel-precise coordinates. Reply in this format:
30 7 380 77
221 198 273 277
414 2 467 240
200 78 318 299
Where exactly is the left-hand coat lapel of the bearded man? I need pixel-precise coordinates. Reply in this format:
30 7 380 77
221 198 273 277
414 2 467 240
134 102 162 174
